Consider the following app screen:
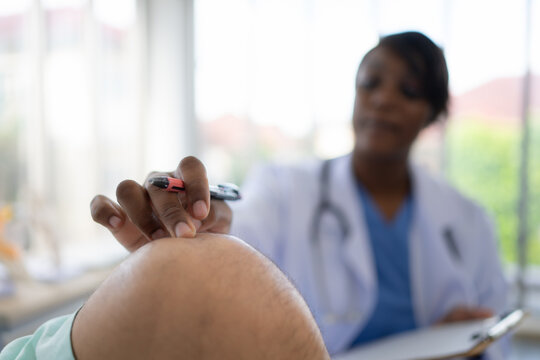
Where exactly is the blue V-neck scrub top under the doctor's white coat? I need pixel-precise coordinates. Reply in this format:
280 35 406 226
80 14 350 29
351 184 417 347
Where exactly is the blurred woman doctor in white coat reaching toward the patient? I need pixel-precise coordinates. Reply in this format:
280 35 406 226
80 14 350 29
92 32 507 360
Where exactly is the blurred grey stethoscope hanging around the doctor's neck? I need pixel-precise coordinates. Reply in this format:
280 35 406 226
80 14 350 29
310 160 462 325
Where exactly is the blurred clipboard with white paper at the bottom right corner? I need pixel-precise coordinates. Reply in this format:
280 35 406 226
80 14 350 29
332 309 528 360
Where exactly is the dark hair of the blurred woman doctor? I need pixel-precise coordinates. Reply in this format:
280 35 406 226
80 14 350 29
360 31 449 126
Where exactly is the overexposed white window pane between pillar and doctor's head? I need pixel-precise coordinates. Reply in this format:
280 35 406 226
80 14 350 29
195 0 377 182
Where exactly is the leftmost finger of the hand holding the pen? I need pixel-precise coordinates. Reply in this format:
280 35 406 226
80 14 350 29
90 195 152 252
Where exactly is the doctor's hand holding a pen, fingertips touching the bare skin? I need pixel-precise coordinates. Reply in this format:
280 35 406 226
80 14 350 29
90 156 232 252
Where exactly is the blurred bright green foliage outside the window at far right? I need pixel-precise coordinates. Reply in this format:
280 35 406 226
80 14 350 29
447 118 540 264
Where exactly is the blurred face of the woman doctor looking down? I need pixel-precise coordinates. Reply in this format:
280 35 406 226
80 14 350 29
353 47 432 160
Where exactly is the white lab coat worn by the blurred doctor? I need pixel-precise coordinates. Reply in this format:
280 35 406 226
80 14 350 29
231 155 507 360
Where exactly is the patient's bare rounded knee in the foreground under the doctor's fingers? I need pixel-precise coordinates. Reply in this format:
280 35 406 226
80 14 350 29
72 234 330 360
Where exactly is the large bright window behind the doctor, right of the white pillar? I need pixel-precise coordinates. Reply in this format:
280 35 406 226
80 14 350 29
195 0 540 306
